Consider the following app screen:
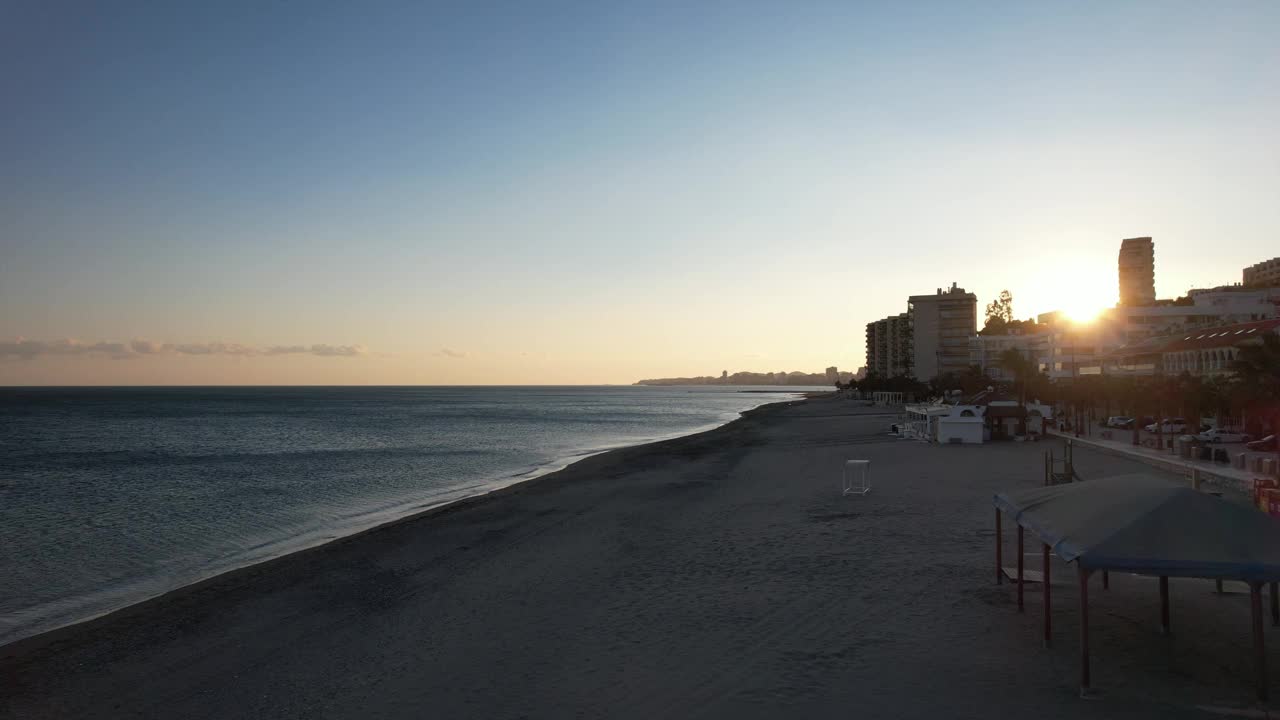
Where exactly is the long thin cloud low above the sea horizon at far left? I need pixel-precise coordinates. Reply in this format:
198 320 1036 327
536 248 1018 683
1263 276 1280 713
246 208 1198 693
0 337 369 360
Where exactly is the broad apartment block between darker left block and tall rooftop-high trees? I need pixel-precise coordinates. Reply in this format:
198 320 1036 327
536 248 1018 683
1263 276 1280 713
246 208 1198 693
908 283 978 379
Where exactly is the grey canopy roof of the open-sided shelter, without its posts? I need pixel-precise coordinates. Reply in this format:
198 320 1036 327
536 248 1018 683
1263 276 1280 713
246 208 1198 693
995 474 1280 582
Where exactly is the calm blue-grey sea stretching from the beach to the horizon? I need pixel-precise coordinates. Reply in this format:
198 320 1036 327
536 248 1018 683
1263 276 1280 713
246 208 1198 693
0 387 814 643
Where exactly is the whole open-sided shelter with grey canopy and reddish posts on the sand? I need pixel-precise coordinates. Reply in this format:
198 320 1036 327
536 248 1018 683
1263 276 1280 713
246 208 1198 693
995 473 1280 701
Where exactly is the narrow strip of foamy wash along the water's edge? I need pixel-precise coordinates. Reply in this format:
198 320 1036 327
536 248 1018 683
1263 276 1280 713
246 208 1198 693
0 391 814 660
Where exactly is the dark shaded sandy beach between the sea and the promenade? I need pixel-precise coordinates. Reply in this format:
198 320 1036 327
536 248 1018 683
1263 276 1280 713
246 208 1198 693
0 398 1280 719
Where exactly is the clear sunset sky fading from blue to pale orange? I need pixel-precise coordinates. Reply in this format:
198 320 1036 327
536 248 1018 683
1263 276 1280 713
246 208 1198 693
0 0 1280 384
